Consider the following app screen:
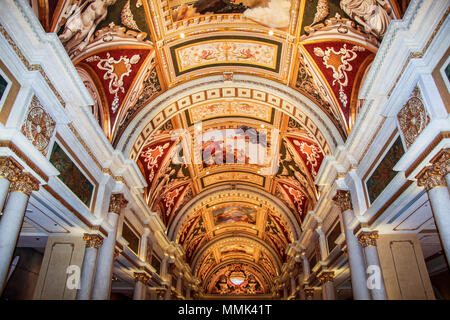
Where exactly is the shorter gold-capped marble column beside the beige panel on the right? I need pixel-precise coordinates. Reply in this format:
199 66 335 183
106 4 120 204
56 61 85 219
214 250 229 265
358 231 387 300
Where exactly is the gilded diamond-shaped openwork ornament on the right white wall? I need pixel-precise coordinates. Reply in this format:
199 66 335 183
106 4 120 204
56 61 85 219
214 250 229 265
397 87 430 148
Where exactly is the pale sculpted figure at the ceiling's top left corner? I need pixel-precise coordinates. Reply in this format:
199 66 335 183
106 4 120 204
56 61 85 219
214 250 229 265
59 0 116 55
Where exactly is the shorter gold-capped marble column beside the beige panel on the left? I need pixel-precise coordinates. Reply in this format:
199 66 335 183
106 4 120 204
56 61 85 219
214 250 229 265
77 233 103 300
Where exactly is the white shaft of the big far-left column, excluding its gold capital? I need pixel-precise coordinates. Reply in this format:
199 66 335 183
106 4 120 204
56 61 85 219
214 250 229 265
0 192 29 295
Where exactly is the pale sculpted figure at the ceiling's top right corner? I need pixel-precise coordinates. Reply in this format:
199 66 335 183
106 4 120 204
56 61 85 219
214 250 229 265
341 0 391 38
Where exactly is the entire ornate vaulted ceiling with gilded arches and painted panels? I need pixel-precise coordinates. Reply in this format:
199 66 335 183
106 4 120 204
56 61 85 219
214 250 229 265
41 0 400 294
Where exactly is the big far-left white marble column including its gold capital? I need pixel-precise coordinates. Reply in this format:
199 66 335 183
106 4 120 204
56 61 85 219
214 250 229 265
0 174 39 295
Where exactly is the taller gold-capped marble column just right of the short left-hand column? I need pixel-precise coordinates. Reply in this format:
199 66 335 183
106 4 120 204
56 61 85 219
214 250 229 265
92 194 128 300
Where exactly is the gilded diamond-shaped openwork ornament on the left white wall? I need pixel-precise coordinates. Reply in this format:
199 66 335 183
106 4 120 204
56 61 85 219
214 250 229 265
21 96 56 156
